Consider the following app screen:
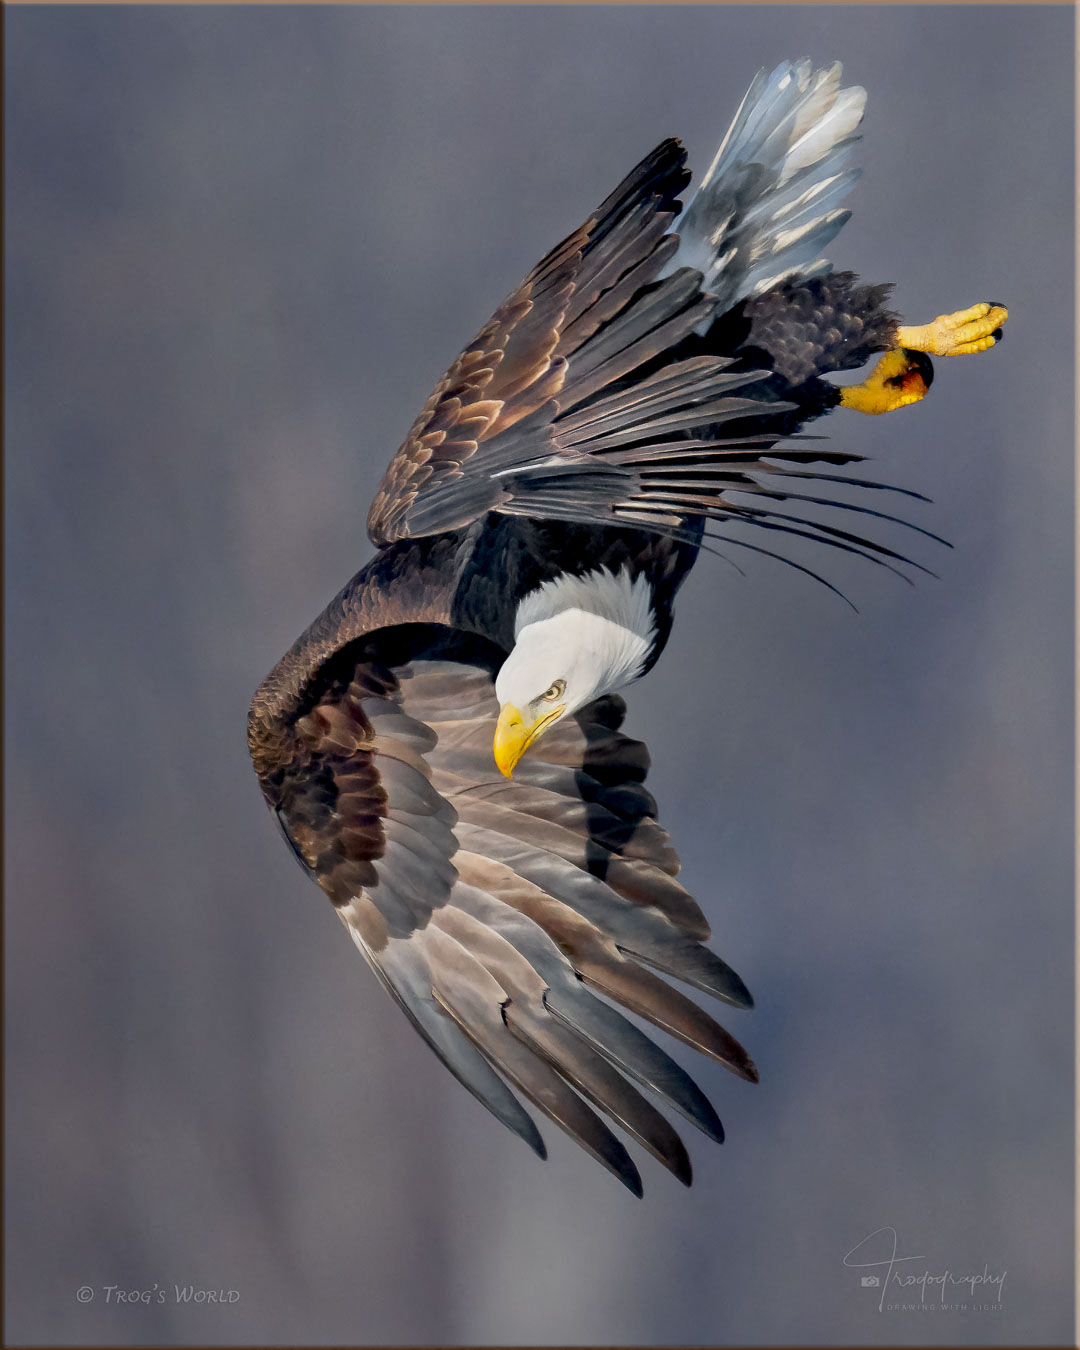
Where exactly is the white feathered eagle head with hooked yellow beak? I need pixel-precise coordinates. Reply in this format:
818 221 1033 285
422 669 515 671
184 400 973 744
494 567 656 778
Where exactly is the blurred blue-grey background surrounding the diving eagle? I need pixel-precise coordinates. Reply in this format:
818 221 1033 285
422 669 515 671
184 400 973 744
4 5 1073 1345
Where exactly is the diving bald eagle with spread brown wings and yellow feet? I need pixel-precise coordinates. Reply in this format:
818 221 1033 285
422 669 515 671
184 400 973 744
248 61 1007 1195
